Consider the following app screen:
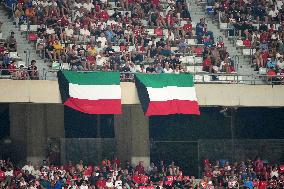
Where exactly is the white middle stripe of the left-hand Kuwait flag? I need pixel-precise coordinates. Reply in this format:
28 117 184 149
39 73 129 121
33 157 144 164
69 83 121 100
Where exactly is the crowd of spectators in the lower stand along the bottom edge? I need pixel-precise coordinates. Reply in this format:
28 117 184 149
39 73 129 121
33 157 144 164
0 158 284 189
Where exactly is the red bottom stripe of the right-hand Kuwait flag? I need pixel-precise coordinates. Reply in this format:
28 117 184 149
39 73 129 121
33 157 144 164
145 100 200 116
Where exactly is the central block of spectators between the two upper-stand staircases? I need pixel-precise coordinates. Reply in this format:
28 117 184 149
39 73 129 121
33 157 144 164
0 0 239 79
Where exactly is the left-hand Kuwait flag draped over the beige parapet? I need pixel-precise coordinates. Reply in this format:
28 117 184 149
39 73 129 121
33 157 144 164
58 71 121 114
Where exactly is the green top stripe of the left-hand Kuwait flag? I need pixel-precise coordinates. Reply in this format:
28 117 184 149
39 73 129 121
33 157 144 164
62 70 120 85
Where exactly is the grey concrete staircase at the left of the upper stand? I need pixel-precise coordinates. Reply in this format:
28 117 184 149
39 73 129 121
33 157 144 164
0 5 56 79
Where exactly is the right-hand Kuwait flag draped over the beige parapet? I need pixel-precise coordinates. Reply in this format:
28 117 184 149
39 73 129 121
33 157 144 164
135 74 200 116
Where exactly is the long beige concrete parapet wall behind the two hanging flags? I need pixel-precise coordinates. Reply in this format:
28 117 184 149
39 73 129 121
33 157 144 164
0 80 284 107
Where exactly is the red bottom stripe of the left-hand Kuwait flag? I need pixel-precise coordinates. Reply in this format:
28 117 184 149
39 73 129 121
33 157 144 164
64 98 122 114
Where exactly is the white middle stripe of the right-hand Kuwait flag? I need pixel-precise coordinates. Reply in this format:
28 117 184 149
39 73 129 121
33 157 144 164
147 86 197 101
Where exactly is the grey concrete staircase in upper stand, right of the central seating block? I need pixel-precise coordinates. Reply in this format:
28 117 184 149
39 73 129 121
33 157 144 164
188 0 256 82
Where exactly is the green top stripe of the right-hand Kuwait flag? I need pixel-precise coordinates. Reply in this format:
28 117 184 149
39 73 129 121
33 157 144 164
135 73 194 88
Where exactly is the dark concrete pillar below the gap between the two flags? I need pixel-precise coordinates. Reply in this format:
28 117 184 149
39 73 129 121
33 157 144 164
114 105 150 167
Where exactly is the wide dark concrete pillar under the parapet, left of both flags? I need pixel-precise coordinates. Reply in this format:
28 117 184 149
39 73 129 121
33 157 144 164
10 103 64 163
